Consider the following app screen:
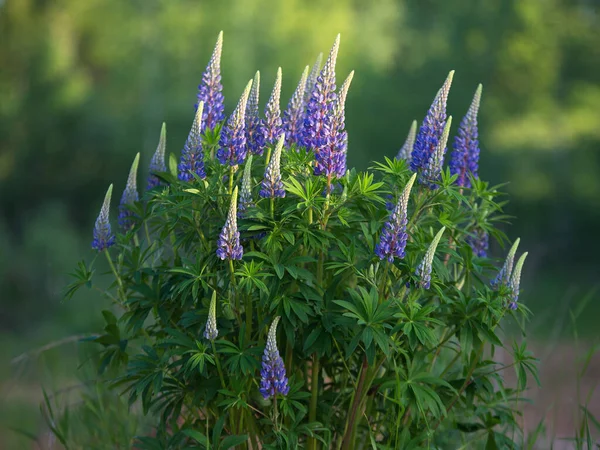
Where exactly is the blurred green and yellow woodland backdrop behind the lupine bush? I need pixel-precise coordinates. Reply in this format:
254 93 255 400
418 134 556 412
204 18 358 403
0 0 600 448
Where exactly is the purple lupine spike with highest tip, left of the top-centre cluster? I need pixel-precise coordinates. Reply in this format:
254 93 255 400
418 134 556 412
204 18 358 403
195 31 225 132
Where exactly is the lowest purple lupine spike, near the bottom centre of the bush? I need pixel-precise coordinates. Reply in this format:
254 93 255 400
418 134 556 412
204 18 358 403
259 316 290 400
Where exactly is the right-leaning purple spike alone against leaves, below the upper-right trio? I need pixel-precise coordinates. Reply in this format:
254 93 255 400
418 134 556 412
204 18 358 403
375 173 417 262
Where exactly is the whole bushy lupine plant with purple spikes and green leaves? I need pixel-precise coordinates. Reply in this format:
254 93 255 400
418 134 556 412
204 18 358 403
62 35 537 450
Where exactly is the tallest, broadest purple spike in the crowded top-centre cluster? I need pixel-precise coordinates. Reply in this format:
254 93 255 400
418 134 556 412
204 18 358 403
302 34 340 151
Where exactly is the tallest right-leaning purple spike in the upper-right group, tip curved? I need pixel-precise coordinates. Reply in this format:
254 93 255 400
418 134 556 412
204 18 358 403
410 71 454 177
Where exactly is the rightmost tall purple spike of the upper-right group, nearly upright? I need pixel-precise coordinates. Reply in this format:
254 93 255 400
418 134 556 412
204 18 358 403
449 84 483 187
